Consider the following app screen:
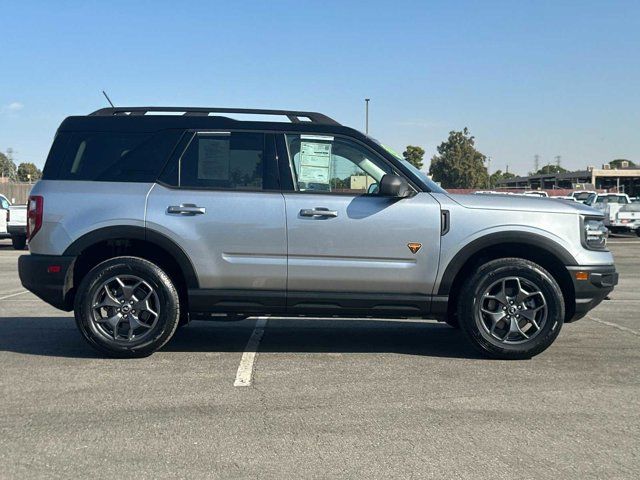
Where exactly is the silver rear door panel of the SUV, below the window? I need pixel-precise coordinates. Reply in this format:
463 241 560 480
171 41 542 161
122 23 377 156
146 185 287 292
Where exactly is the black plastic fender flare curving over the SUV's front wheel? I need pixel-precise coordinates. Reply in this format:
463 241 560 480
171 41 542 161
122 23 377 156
438 232 578 295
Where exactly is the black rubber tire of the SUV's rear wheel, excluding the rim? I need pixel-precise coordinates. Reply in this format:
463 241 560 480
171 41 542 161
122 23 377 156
74 257 180 357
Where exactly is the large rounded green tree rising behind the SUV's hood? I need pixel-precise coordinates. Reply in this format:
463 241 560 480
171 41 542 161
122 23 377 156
429 127 489 188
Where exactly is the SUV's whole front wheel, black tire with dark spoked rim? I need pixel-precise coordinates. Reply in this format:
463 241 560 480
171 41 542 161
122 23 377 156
458 258 565 359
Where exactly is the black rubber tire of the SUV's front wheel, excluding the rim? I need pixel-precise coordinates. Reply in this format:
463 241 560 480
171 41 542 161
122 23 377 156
459 259 565 358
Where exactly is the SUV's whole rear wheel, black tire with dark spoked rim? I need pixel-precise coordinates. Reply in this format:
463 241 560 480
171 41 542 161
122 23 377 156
74 257 180 358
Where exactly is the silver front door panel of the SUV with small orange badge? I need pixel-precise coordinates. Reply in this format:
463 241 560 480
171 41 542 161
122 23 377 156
284 193 440 295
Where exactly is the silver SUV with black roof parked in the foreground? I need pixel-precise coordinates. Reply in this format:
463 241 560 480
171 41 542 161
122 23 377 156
19 107 618 358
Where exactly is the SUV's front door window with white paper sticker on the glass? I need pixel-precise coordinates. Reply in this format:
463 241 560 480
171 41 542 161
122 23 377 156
287 135 392 195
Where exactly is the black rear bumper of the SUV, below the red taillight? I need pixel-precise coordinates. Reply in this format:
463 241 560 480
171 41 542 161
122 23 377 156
18 254 76 312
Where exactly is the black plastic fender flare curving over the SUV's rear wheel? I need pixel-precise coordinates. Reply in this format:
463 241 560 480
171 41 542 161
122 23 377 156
63 225 199 288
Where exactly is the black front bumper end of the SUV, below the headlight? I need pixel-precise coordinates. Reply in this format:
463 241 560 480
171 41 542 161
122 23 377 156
567 265 618 323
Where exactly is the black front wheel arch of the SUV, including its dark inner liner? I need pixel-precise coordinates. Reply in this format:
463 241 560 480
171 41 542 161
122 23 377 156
438 232 578 319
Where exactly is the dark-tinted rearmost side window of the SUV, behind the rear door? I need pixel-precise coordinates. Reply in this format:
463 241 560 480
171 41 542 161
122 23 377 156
43 130 182 182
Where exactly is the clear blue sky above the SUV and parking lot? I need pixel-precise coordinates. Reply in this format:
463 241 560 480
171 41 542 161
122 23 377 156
0 0 640 173
